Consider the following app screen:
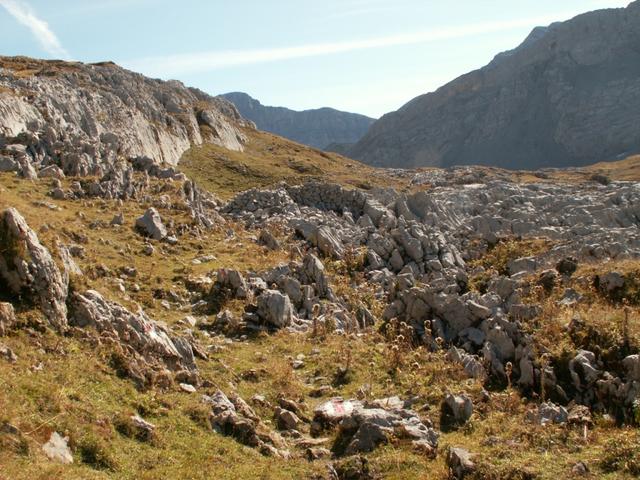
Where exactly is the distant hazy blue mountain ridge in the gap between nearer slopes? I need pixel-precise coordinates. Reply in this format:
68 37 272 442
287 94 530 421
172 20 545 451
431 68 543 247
222 92 374 149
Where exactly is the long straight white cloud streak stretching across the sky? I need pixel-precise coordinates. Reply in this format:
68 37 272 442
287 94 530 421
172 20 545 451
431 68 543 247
123 14 592 78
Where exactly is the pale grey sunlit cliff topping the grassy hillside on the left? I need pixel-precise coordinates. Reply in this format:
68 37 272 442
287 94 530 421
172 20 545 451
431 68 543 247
0 57 250 170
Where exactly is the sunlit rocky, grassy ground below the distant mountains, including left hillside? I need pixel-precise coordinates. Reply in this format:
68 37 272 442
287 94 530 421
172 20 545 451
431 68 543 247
0 49 640 480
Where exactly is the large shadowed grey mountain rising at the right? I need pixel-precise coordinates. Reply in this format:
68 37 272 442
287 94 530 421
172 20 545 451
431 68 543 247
349 1 640 168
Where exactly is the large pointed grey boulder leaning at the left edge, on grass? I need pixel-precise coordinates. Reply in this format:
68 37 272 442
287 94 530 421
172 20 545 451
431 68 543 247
0 208 68 331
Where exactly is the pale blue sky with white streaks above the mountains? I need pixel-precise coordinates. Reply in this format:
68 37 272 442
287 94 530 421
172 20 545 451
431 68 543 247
0 0 630 117
